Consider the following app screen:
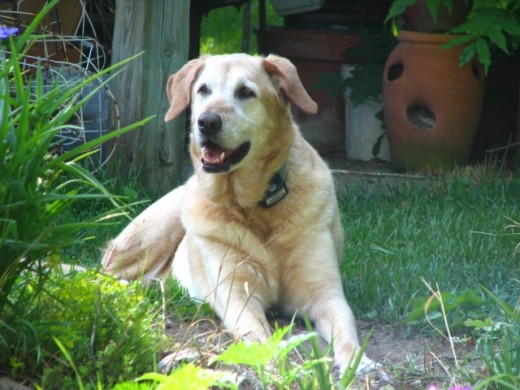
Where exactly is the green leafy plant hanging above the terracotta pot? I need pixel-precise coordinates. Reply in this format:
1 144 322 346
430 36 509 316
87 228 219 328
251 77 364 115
386 0 520 73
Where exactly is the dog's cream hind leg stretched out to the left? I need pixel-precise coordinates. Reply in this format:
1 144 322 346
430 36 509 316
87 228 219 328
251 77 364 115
102 186 185 280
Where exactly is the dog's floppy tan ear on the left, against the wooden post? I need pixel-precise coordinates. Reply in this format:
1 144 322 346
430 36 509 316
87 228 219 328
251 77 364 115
164 57 204 122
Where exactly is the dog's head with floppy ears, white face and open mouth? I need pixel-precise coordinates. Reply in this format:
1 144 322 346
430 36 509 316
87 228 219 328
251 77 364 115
165 54 318 173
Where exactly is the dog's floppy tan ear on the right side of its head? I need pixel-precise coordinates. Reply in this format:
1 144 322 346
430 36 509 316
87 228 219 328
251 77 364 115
263 54 318 114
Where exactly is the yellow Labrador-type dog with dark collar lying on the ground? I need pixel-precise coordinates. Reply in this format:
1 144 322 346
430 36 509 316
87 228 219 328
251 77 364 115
102 54 372 372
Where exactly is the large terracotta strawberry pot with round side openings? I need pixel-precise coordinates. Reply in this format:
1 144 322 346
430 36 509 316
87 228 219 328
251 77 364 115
383 31 484 171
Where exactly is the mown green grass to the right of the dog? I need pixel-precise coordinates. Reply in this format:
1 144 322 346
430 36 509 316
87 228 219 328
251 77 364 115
340 168 520 325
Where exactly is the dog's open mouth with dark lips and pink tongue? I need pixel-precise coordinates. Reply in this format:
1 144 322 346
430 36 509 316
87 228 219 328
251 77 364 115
201 141 251 173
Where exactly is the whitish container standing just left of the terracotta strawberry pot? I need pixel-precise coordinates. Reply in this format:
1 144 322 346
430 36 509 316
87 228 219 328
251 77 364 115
341 65 390 161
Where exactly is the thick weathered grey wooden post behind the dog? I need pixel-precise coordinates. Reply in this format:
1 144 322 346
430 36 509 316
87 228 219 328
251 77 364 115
111 0 190 194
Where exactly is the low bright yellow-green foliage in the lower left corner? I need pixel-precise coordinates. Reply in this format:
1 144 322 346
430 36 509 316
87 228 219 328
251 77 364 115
0 271 161 388
